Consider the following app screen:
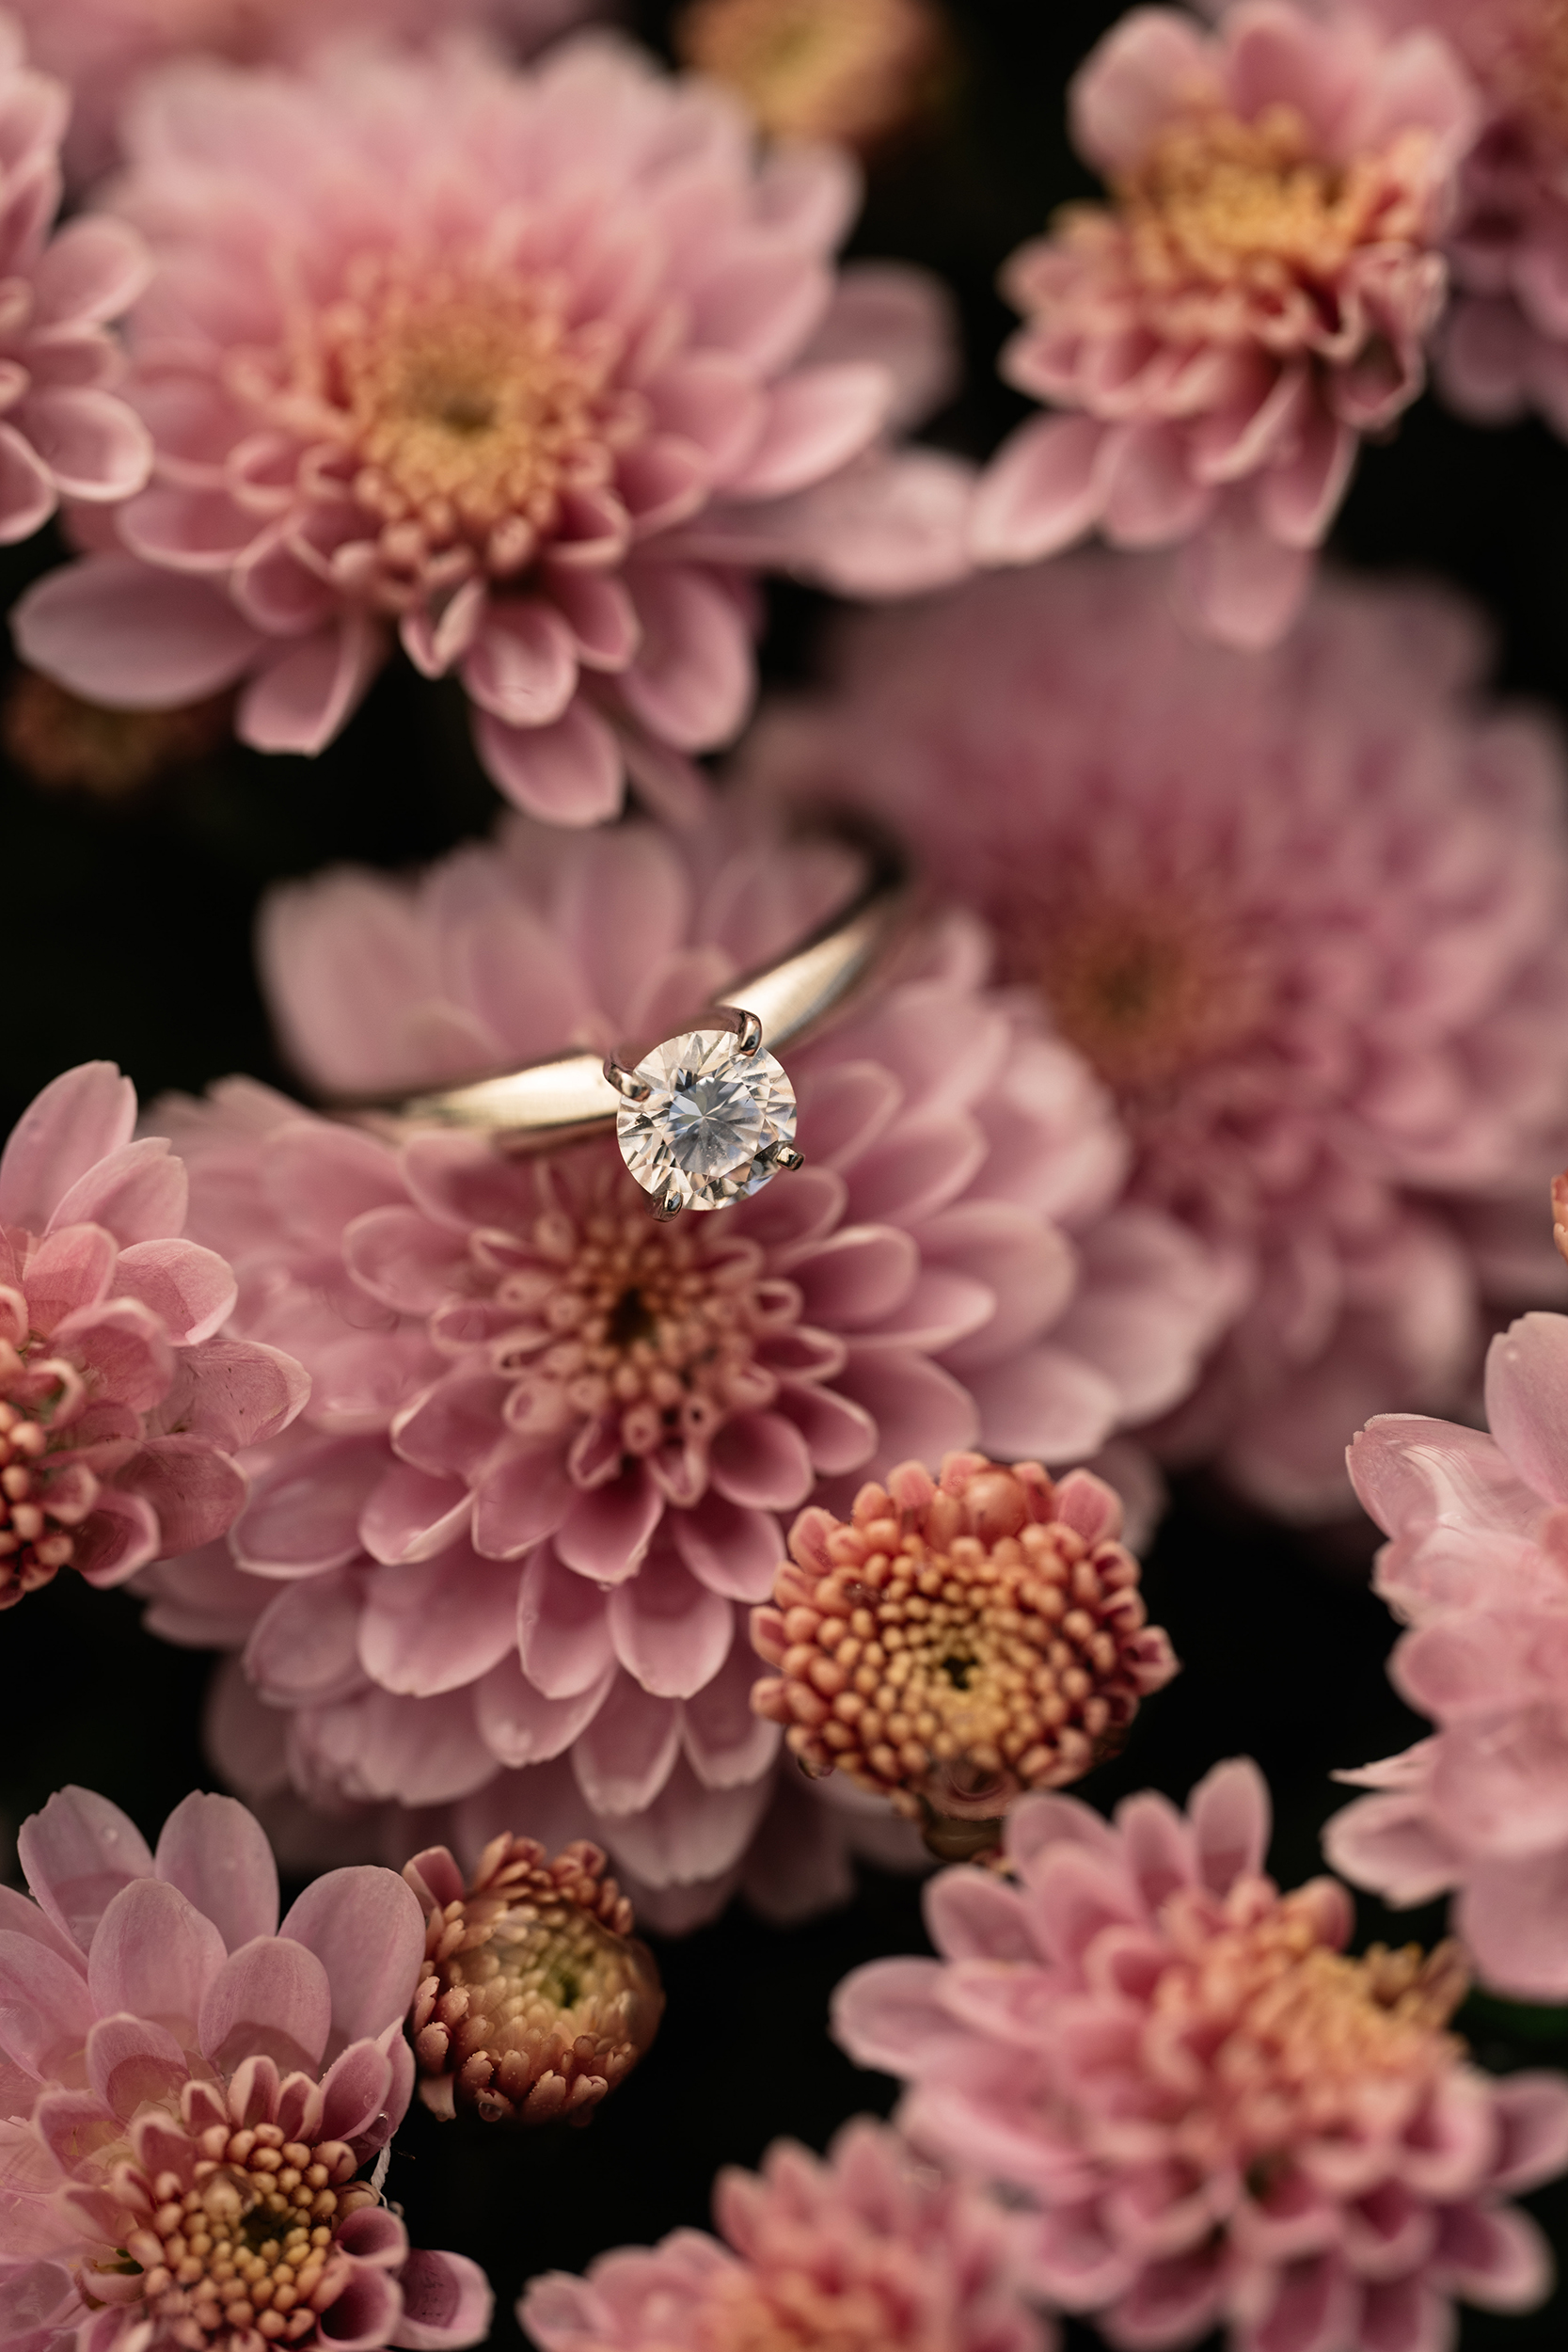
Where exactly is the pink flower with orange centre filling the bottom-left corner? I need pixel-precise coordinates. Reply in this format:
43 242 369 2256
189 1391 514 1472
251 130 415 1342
0 1788 491 2352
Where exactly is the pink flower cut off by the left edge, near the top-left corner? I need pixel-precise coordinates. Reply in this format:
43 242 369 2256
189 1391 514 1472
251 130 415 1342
0 14 152 546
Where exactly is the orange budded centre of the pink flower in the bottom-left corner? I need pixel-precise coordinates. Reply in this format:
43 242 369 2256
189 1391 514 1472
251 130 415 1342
124 2124 376 2347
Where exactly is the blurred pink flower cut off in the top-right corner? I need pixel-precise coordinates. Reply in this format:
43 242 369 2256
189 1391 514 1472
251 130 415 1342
1297 0 1568 436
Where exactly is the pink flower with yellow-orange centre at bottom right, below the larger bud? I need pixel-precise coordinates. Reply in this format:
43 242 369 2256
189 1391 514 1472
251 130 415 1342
834 1762 1568 2352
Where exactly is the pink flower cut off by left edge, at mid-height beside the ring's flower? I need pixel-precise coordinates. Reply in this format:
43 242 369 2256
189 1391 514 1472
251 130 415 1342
0 1061 308 1609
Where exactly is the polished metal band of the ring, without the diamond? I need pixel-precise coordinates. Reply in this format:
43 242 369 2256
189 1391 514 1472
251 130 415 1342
342 823 912 1155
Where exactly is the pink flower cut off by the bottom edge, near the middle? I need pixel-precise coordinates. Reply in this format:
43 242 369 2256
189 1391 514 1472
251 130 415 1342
517 2120 1051 2352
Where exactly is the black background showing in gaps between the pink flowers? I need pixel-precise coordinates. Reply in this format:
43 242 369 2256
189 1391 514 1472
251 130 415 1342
0 0 1568 2352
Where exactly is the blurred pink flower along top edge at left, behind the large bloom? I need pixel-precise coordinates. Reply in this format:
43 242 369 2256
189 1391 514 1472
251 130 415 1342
11 0 604 186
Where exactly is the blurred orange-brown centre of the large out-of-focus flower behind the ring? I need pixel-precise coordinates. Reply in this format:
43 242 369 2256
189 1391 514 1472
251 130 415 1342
1039 901 1265 1094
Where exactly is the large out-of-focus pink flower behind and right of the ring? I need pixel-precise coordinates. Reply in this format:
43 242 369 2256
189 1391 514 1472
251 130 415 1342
750 555 1568 1518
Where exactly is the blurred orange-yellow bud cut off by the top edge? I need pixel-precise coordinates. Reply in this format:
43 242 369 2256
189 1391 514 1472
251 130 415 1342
674 0 945 149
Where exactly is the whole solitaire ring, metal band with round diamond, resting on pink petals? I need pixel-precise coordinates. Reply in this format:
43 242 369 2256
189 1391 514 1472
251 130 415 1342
336 826 910 1218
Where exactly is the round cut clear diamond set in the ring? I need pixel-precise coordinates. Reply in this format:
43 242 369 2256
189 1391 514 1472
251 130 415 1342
616 1030 795 1209
